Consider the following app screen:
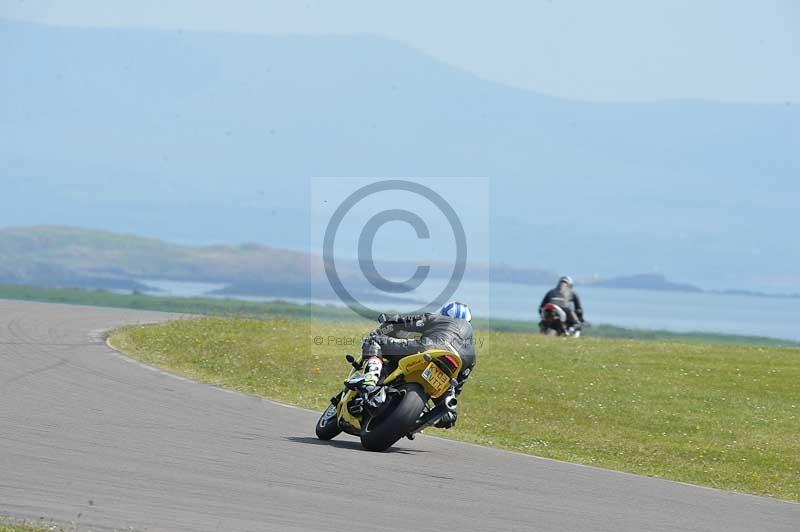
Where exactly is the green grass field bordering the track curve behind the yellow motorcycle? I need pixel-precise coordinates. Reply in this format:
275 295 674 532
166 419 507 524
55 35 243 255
111 318 800 501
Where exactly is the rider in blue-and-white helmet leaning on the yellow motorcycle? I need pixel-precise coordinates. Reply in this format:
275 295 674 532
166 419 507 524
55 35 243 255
361 301 476 428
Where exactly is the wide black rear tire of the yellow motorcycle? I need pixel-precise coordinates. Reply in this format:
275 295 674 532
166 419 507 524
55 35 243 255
361 382 428 451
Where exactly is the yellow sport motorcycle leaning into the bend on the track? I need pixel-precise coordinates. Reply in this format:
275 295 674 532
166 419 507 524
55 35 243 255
316 349 462 451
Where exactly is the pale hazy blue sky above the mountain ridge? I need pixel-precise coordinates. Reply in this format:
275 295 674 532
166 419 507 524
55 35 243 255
6 0 800 102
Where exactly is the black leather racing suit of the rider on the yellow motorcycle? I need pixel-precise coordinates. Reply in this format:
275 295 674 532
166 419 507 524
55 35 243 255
362 313 477 392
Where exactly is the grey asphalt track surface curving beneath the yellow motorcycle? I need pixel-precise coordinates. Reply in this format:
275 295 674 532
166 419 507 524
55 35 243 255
0 300 800 532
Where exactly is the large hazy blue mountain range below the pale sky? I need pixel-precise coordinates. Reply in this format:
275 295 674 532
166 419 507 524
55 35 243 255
0 20 800 291
